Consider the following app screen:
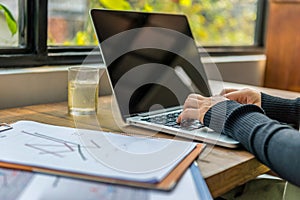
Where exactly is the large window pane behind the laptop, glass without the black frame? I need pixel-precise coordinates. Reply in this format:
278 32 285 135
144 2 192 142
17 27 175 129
48 0 258 46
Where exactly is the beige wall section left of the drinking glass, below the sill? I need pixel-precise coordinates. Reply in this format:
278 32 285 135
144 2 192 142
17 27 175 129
0 71 67 108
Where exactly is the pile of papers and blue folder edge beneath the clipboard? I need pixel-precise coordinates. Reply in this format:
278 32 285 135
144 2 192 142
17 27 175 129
0 162 213 200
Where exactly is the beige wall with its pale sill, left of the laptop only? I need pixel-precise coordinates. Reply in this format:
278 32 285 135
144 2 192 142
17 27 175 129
0 67 111 109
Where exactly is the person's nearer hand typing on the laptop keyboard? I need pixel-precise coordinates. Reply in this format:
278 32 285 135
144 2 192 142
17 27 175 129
177 94 228 123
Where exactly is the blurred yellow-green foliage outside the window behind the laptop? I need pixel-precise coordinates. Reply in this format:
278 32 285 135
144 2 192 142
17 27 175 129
59 0 257 46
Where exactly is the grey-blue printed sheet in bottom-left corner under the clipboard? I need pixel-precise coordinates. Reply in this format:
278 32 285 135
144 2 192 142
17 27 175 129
0 168 34 200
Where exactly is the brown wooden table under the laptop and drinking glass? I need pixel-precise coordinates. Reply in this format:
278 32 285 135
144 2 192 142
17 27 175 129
0 84 299 197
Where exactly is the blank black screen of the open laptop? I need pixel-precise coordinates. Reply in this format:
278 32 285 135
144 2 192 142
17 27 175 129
91 9 210 119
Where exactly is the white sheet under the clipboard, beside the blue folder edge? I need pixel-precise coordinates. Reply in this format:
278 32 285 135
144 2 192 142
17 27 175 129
13 167 202 200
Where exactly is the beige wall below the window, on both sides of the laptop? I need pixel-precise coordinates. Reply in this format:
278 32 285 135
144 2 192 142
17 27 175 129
0 56 265 109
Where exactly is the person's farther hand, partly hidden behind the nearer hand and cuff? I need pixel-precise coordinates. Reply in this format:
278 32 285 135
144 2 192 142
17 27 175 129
221 88 261 107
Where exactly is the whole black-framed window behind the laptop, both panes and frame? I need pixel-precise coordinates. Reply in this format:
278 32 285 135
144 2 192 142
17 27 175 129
0 0 266 67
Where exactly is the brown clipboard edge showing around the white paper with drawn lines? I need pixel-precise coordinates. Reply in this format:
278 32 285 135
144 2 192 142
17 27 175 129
0 121 205 190
